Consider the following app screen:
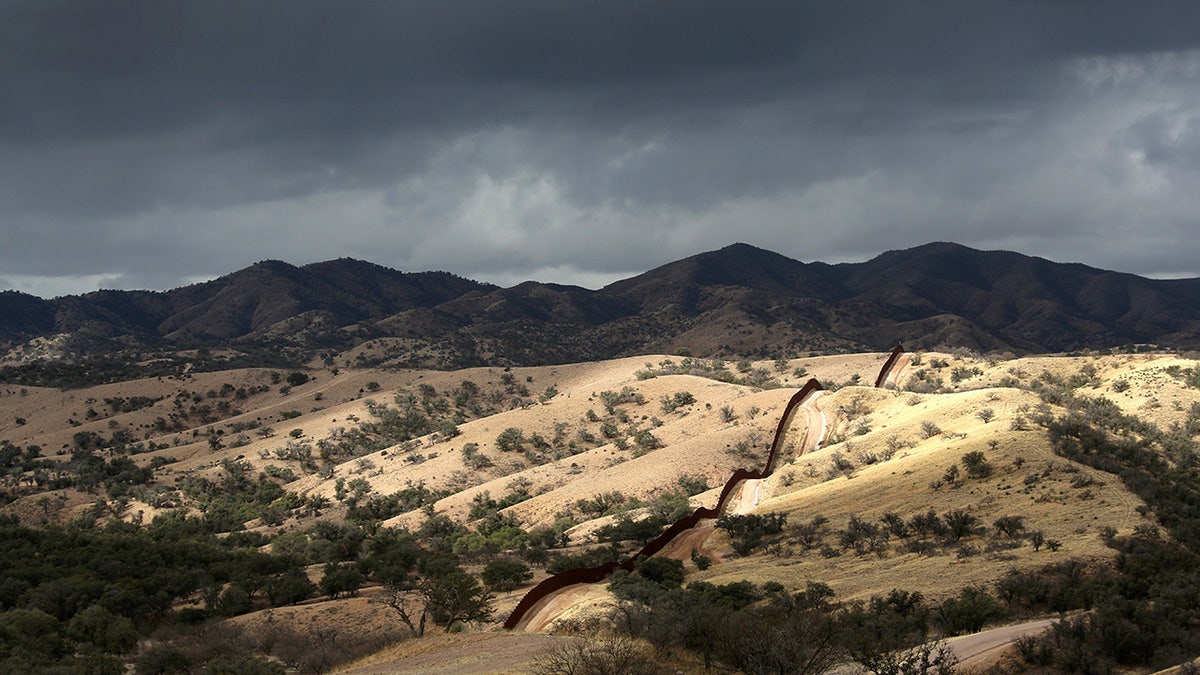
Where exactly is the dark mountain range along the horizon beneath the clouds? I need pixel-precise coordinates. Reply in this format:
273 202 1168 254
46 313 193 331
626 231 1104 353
0 243 1200 368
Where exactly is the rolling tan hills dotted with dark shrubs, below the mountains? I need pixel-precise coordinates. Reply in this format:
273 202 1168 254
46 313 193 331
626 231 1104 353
0 352 1200 673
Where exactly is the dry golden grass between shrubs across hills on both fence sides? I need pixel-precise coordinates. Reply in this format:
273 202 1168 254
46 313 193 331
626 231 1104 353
0 345 1200 673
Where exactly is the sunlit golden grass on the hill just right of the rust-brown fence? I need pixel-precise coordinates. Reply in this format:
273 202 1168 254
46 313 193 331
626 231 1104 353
697 389 1146 598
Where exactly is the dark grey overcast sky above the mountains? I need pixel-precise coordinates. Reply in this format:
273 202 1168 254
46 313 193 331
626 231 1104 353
0 0 1200 297
